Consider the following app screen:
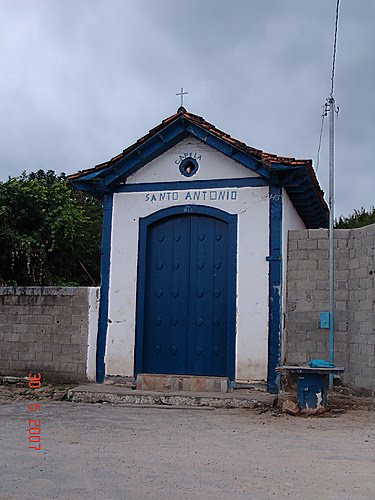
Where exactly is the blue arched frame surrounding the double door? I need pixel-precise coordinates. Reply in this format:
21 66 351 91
134 205 237 381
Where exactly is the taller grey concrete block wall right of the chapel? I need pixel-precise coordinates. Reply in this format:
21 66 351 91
285 224 375 392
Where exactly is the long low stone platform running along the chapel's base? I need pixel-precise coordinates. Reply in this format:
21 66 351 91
68 384 276 409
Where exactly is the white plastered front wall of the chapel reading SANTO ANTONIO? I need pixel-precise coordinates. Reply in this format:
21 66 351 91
105 139 269 381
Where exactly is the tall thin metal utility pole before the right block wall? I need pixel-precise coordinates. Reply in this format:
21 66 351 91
328 96 335 390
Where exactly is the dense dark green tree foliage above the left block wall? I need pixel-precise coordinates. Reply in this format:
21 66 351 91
0 170 102 286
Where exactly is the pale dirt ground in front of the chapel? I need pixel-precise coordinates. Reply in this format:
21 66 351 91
0 391 375 500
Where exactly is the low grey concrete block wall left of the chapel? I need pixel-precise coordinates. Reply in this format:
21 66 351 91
0 287 99 382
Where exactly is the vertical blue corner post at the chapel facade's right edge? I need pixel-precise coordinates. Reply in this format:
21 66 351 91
267 185 282 393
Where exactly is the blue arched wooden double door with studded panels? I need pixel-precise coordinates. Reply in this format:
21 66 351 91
142 214 235 376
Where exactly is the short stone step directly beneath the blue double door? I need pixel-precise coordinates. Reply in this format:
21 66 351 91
136 373 228 393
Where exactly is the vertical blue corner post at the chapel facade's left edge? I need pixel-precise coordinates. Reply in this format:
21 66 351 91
96 194 113 384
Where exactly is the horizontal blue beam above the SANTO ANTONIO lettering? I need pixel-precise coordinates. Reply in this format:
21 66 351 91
114 177 269 193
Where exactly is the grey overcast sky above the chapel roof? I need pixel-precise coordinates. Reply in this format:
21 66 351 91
0 0 375 216
